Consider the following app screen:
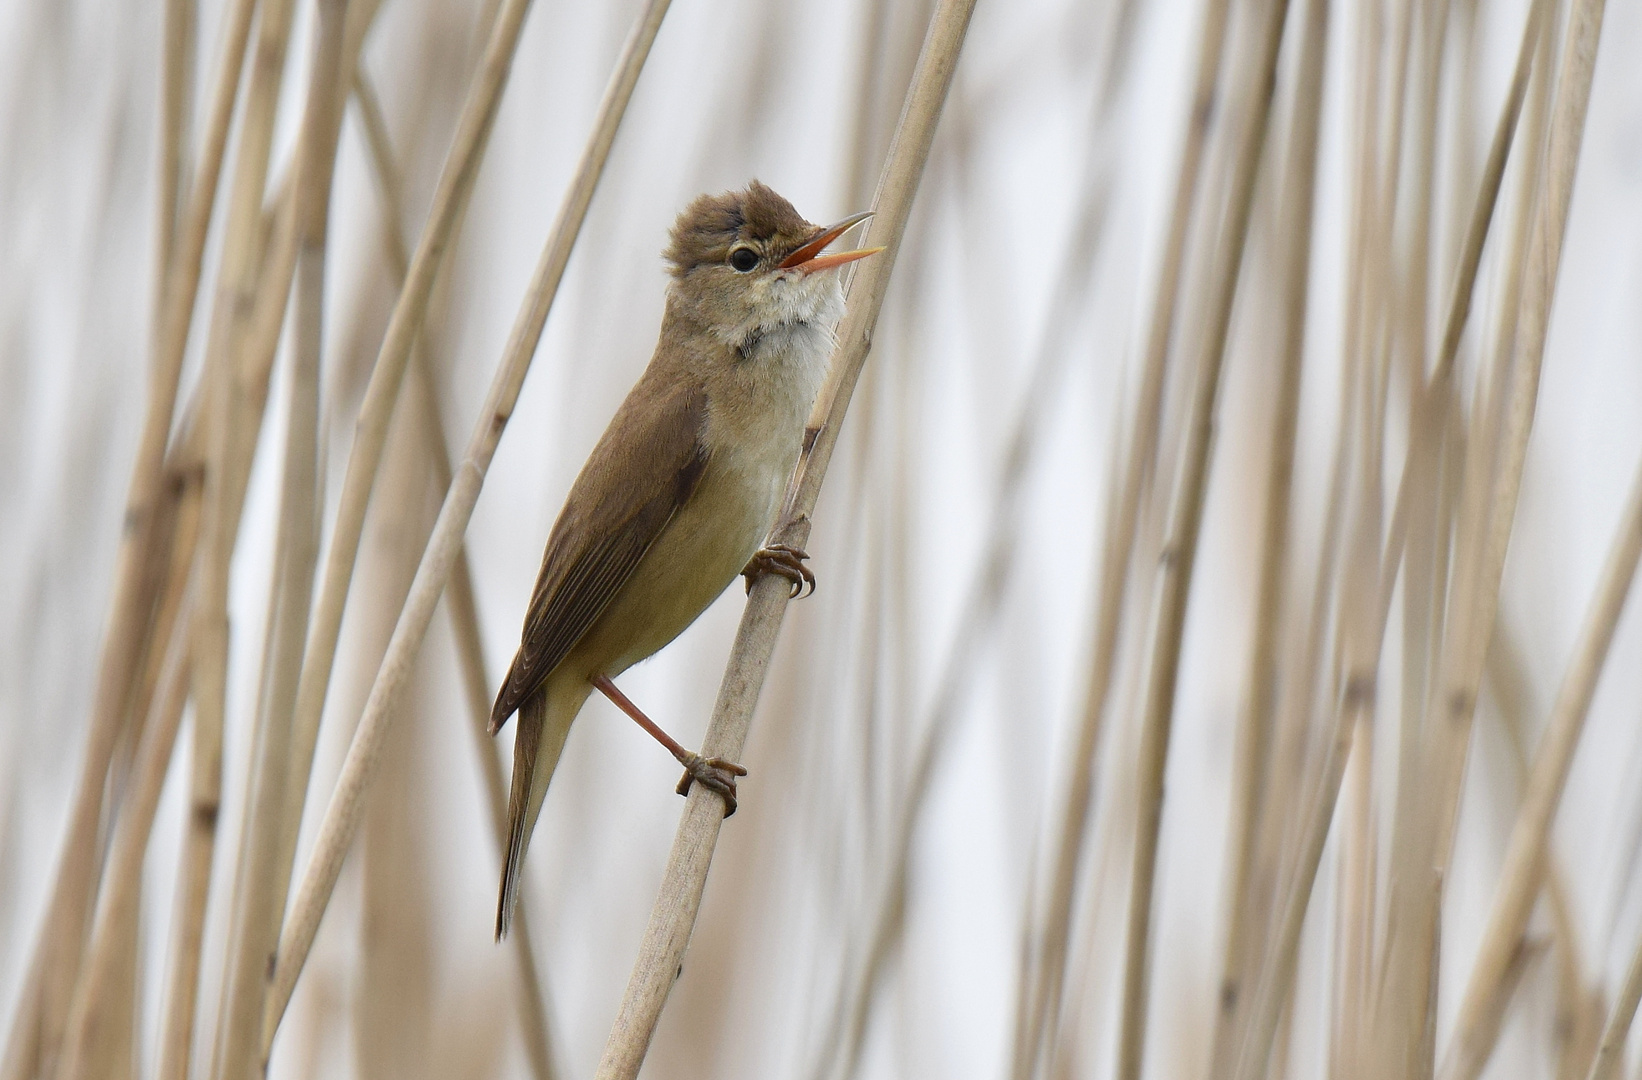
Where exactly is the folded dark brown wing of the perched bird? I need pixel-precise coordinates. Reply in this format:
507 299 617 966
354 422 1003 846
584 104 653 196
491 373 708 734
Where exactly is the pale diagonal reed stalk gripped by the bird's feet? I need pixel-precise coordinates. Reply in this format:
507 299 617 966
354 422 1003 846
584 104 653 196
594 0 975 1080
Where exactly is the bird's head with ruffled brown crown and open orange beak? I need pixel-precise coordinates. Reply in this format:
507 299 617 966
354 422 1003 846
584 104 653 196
665 181 883 348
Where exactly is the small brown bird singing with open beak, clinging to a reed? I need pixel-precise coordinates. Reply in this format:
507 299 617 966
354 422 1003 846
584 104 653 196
491 181 882 940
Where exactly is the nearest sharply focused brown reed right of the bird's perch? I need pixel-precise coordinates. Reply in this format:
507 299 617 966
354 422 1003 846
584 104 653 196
1117 0 1289 1063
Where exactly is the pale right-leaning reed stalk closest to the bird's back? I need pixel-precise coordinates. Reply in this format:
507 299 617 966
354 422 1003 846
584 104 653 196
263 0 668 1043
